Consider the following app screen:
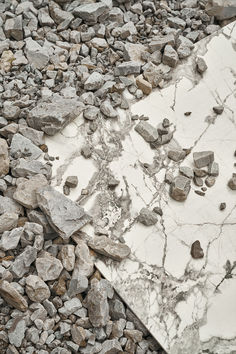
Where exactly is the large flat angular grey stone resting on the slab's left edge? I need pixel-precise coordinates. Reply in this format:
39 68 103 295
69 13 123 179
36 186 91 239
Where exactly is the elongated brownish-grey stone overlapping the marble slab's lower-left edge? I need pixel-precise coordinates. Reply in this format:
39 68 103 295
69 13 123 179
88 236 130 261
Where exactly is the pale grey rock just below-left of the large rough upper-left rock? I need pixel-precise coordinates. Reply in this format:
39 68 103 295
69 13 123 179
10 133 42 160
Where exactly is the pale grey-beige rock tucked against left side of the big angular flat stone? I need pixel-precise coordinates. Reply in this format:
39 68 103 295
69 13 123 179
13 175 48 209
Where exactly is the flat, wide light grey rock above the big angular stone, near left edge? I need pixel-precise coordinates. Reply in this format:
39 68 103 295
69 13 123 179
11 158 52 179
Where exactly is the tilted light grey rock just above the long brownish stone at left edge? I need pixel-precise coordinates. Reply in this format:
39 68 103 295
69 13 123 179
11 246 37 278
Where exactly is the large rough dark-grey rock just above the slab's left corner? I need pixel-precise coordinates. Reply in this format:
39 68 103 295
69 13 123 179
27 95 85 135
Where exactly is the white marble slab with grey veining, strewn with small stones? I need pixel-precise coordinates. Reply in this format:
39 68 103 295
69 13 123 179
46 23 236 354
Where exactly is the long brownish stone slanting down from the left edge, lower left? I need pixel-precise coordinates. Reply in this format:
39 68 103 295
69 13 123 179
0 280 28 311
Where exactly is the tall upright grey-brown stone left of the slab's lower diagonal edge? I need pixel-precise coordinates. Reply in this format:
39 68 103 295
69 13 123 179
87 279 109 327
